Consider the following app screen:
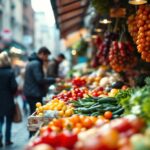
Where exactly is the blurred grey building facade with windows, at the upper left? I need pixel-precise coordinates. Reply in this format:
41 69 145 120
0 0 34 49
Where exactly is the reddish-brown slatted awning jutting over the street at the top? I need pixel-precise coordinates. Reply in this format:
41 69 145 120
51 0 89 38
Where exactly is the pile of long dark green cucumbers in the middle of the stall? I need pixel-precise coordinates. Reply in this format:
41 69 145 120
72 97 124 119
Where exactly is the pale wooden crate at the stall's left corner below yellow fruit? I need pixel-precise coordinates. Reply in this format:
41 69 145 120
27 112 53 131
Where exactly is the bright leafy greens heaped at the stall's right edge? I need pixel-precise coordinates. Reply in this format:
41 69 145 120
116 77 150 122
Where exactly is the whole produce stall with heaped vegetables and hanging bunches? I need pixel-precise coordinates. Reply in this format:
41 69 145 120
26 0 150 150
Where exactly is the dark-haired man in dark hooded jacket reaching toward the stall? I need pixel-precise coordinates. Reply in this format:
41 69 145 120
23 47 56 114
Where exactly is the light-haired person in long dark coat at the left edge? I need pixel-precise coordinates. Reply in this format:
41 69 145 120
0 52 17 147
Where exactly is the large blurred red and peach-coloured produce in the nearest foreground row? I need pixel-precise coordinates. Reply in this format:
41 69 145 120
27 116 145 150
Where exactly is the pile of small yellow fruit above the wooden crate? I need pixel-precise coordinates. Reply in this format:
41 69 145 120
36 98 74 118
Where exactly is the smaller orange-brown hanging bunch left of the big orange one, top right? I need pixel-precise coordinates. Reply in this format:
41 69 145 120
127 15 138 43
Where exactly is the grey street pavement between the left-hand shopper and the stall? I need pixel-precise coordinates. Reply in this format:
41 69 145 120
0 98 30 150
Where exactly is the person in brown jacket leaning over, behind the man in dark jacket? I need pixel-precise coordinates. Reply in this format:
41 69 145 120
47 54 65 77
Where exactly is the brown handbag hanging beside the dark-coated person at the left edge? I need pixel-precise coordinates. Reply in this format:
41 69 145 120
13 102 22 123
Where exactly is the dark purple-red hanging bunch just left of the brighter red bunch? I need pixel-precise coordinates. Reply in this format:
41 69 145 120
97 32 118 65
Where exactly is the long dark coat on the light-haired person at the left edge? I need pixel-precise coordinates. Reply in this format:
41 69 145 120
0 67 17 117
